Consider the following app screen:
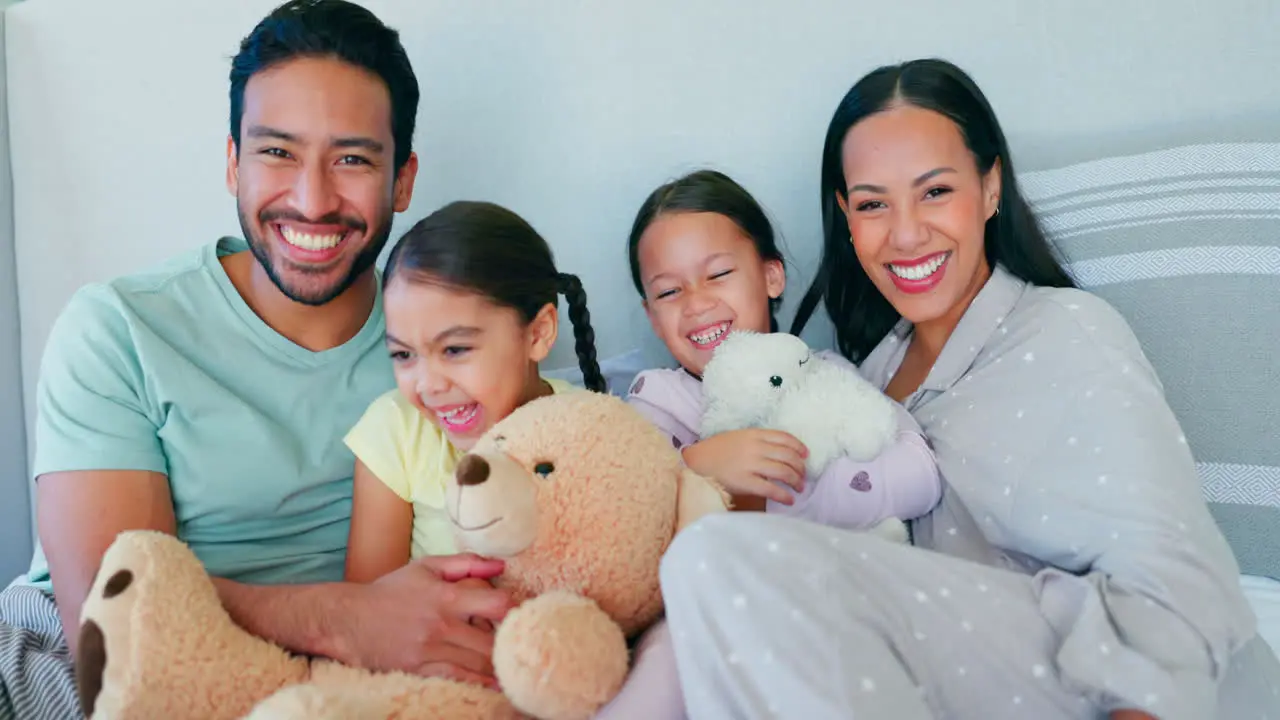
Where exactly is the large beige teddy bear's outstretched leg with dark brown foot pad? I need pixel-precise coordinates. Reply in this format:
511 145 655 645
76 532 516 720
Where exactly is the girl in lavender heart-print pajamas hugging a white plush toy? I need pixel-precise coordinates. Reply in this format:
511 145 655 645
588 165 941 720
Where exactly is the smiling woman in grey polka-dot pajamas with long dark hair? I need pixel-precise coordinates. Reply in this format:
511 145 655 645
663 60 1280 720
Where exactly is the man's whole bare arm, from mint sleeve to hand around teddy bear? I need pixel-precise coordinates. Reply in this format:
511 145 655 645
37 470 511 684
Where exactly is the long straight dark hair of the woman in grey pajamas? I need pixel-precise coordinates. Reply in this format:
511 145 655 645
791 59 1075 363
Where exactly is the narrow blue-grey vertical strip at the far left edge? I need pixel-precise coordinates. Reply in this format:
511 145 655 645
0 0 32 576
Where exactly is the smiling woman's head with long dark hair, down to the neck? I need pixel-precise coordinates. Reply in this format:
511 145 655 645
791 61 1074 361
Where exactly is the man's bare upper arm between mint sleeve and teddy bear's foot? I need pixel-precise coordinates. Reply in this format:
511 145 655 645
36 470 175 656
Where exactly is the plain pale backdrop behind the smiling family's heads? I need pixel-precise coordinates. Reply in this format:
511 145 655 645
8 0 1280 471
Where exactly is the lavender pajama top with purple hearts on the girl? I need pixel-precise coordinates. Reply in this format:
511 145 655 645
627 351 942 529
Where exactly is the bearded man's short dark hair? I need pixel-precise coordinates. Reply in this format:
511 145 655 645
230 0 419 170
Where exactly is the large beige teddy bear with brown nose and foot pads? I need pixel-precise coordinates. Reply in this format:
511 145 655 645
77 391 728 720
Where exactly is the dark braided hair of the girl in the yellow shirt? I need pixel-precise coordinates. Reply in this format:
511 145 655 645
383 201 608 392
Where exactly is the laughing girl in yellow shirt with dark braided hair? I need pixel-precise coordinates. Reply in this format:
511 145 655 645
344 197 605 583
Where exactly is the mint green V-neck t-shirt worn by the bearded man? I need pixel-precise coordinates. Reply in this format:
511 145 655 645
27 238 394 589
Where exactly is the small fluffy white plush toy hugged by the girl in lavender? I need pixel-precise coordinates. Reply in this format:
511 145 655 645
700 331 897 477
